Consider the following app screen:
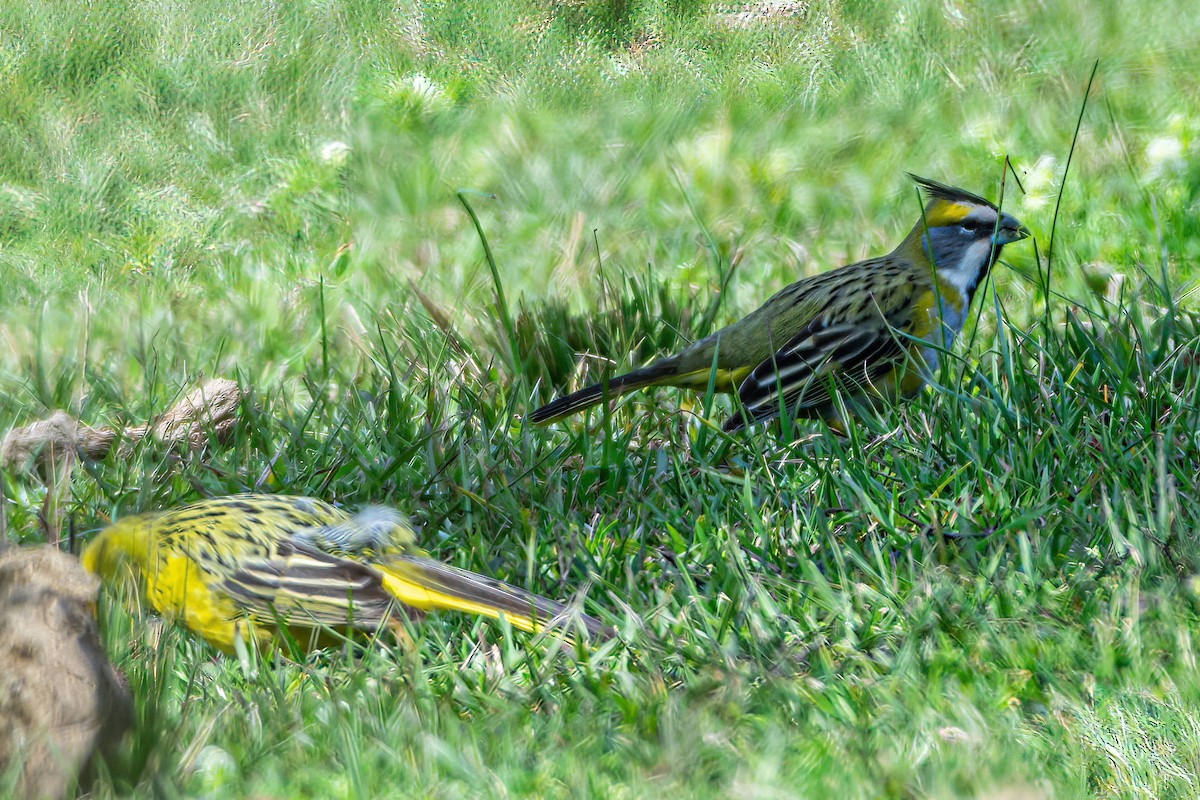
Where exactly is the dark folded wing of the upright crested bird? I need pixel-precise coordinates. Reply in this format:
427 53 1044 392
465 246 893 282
738 318 906 420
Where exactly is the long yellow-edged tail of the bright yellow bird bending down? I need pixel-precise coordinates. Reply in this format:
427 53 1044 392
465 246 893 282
373 555 613 638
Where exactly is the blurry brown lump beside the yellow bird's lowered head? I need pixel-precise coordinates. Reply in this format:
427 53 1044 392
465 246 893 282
0 547 132 798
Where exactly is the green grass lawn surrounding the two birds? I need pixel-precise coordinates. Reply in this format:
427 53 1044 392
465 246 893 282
0 0 1200 798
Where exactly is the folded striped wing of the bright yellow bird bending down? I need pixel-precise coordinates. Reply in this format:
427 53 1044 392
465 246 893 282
221 542 395 630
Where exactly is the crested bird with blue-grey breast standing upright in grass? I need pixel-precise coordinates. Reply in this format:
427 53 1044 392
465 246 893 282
529 175 1030 431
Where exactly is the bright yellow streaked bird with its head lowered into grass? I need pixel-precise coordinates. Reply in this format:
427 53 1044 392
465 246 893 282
82 494 611 652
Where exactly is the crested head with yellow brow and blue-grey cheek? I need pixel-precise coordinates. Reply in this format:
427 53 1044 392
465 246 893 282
900 174 1030 303
